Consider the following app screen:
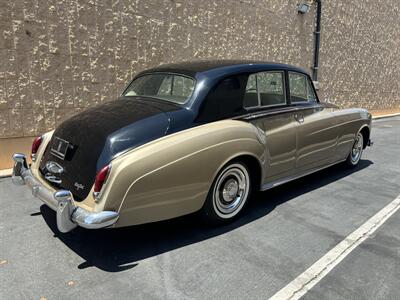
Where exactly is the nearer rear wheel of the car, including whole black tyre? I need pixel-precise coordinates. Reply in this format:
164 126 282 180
201 161 251 224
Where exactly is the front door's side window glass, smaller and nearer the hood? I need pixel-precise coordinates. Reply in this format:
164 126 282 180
289 73 317 103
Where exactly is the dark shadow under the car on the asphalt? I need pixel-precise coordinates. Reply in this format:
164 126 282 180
40 160 372 272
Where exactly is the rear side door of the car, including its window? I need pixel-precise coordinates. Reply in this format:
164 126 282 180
244 71 297 183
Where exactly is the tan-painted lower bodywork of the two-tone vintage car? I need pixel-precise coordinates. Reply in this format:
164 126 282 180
31 103 371 227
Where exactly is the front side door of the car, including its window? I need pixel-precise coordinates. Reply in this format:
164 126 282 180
288 72 338 173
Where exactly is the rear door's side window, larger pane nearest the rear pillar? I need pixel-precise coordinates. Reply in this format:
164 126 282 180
244 71 286 108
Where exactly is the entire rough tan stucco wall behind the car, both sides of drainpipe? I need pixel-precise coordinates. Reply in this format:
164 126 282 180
0 0 400 138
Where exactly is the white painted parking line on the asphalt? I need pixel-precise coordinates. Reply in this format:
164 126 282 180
270 195 400 300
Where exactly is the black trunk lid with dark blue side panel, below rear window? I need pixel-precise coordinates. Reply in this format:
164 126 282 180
40 97 180 201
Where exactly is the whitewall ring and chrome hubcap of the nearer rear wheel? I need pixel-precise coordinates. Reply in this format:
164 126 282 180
213 163 250 219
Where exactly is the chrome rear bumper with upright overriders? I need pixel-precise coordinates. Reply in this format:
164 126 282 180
12 153 119 233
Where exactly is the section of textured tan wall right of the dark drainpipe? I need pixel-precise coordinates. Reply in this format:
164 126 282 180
320 0 400 109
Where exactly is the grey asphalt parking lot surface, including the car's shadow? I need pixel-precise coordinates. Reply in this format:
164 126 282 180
0 117 400 299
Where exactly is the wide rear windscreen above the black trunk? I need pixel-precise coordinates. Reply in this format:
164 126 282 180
123 73 195 104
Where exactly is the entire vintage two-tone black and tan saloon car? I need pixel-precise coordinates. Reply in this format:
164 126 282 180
13 61 371 232
